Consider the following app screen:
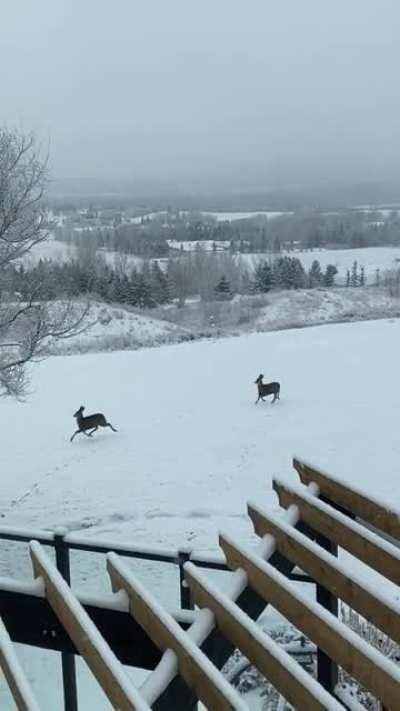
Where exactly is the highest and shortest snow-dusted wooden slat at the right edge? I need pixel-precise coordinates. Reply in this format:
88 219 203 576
293 458 400 540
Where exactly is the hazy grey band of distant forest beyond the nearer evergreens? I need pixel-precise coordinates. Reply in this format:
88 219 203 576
55 210 400 258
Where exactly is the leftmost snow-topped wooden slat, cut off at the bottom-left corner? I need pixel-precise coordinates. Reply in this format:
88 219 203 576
0 618 40 711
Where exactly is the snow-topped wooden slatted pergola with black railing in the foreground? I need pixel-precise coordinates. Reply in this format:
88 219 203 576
0 459 400 711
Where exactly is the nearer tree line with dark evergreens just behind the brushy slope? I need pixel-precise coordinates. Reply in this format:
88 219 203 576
0 253 346 308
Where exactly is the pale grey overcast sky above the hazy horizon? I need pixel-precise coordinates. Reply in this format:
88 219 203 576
0 0 400 187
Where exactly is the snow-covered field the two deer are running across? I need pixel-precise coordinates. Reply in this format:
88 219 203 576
0 319 400 711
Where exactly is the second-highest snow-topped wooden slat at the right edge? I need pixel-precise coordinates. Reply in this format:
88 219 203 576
272 480 400 585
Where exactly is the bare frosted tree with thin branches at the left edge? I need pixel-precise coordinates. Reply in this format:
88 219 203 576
0 128 88 397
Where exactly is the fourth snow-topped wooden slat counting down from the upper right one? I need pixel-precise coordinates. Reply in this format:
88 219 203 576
220 536 400 711
